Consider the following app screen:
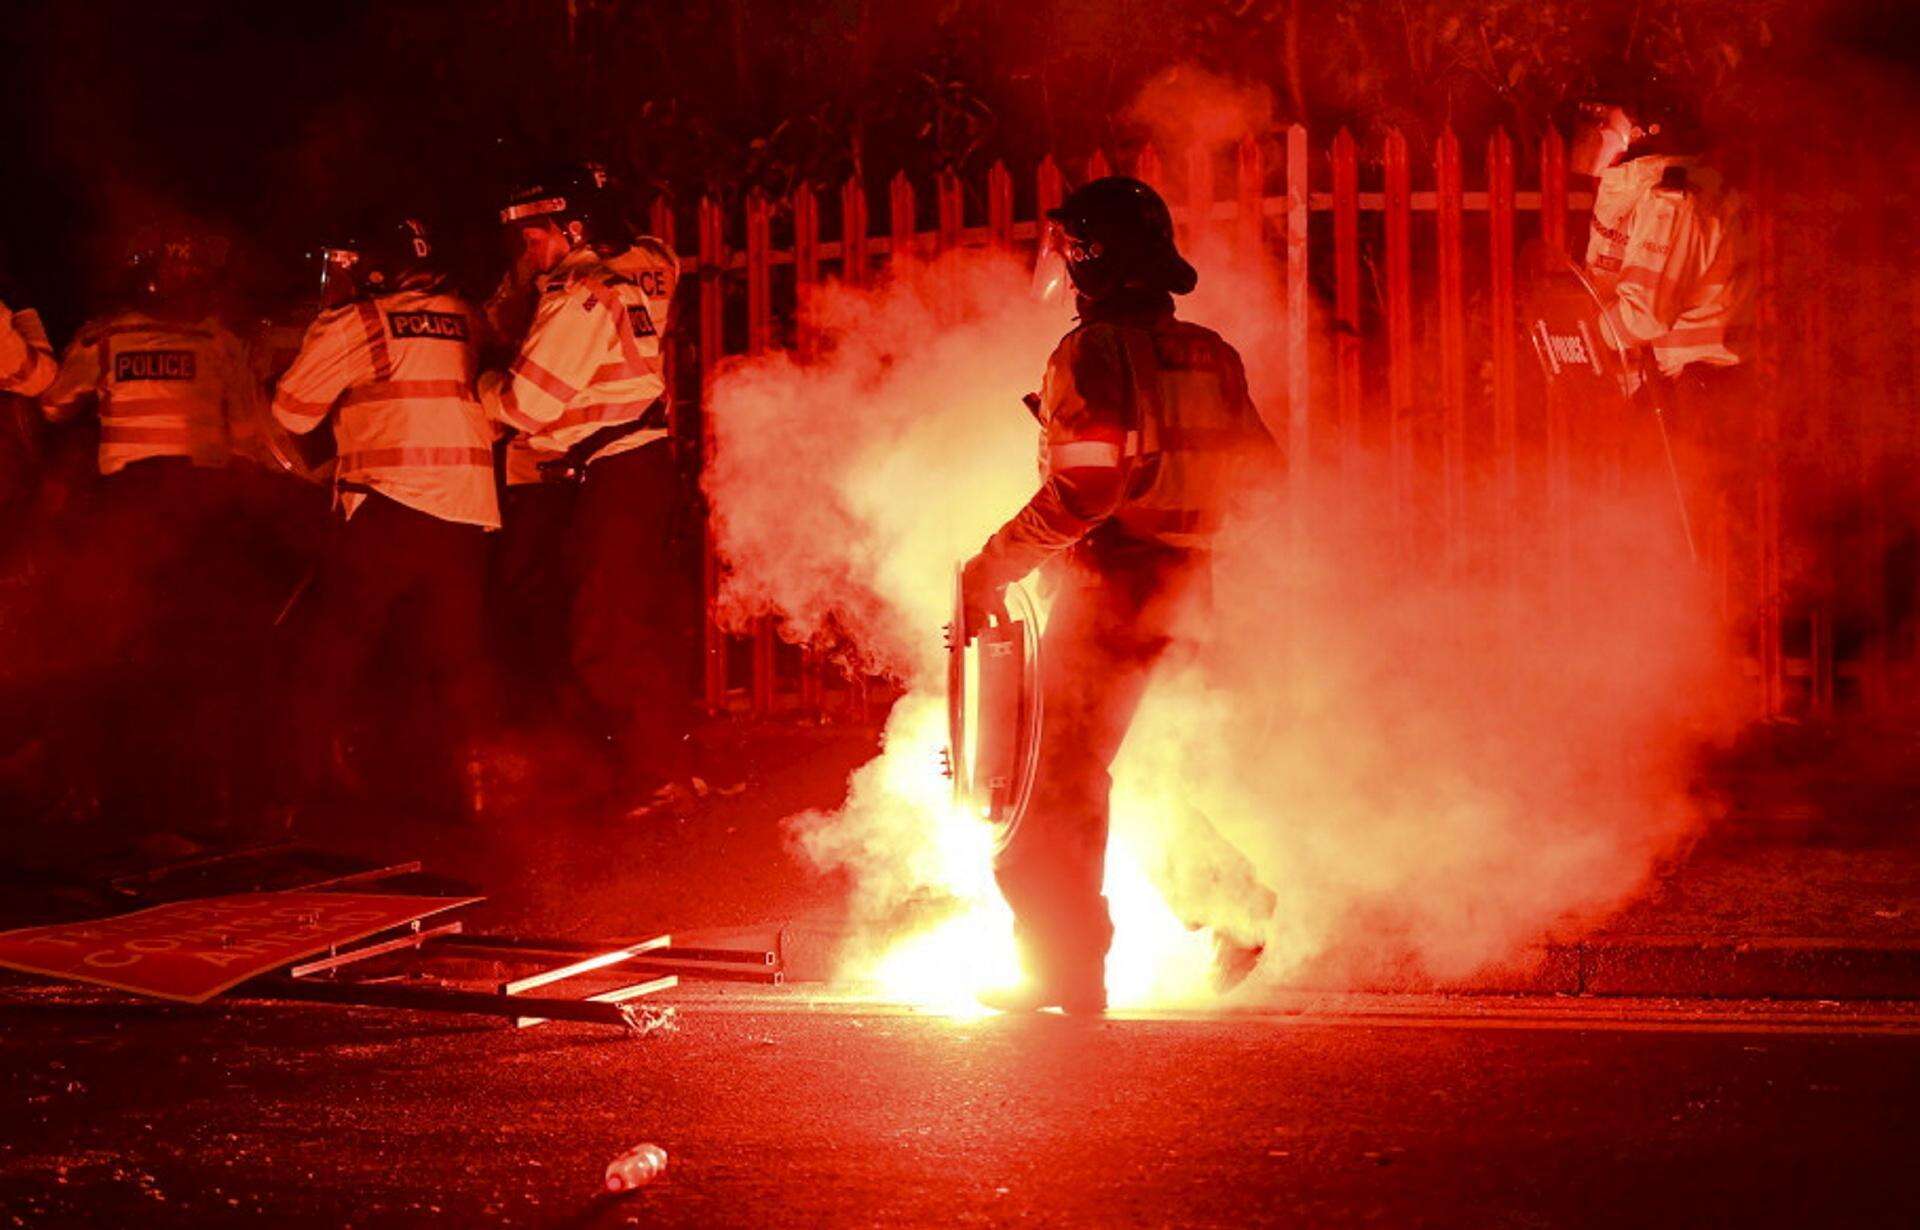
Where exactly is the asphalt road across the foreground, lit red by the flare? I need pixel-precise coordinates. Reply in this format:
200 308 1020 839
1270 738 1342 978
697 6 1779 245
0 988 1920 1226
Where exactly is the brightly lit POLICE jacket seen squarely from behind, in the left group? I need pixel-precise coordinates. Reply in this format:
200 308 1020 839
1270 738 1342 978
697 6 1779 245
273 282 499 530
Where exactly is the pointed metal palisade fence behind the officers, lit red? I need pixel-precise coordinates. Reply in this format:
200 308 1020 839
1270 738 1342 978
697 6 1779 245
651 127 1920 718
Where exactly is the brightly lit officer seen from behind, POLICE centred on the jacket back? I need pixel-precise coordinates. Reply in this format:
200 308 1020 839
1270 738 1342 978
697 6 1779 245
273 217 501 813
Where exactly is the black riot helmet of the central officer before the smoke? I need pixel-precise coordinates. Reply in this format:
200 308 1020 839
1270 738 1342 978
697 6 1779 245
1046 175 1200 299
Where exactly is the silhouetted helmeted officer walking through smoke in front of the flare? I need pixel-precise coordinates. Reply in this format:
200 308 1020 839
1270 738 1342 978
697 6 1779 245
962 177 1273 1011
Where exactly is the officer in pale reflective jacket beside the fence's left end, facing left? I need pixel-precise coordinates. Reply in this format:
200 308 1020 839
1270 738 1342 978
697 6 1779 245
480 165 695 809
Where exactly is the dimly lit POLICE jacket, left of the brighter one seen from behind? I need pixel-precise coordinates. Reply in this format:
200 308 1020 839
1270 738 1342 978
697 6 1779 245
40 311 259 474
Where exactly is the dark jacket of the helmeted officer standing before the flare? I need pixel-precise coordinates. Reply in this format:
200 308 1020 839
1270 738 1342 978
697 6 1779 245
981 296 1273 581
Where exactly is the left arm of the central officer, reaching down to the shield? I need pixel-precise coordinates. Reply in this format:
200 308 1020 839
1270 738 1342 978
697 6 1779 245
975 330 1129 583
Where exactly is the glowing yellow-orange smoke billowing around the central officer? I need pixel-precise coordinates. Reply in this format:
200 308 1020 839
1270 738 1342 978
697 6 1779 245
710 74 1751 1002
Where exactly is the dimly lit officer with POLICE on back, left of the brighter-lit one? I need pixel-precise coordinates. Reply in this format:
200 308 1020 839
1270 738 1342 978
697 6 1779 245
40 225 259 823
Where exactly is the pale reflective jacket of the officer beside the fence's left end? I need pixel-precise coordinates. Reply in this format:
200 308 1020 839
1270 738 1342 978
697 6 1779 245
480 240 680 482
